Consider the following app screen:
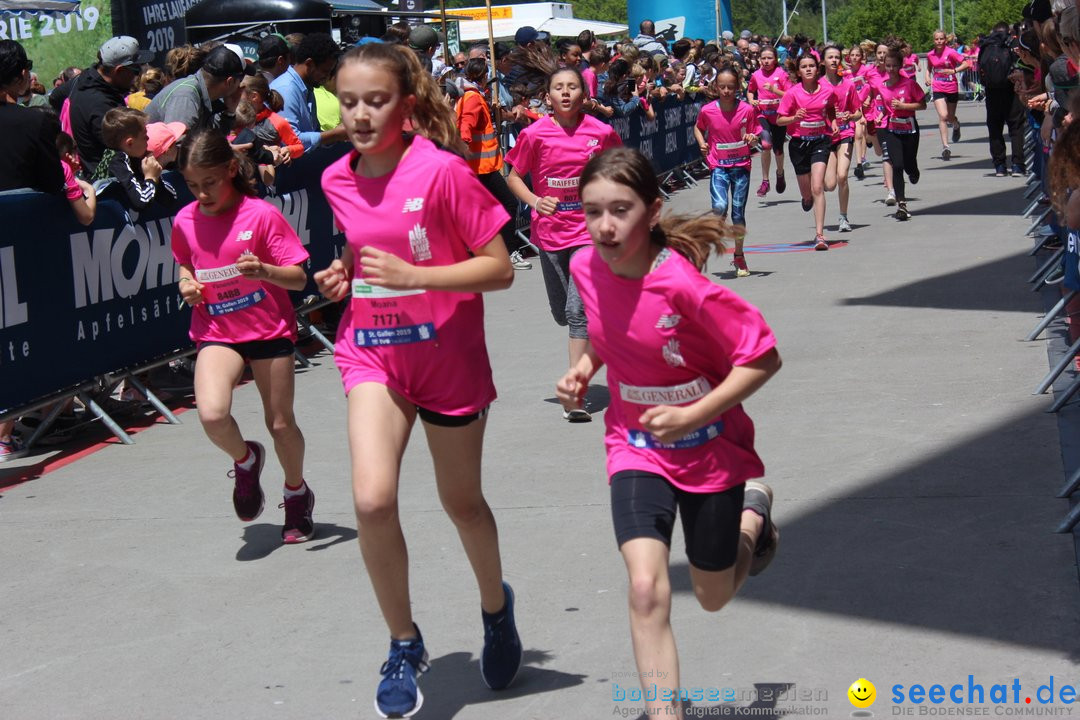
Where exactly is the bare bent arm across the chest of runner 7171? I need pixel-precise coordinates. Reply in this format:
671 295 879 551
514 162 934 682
360 235 514 293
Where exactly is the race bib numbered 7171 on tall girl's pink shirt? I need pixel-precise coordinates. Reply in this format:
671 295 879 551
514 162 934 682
352 280 435 348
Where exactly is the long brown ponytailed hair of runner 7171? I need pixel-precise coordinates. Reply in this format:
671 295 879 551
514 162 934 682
338 42 465 154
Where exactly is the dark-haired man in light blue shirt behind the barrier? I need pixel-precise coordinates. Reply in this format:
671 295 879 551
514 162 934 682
270 32 348 151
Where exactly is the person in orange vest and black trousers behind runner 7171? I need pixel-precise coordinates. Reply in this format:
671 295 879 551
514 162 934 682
454 57 532 270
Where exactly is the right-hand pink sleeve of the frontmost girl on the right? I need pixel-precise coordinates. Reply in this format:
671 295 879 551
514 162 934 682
697 280 777 365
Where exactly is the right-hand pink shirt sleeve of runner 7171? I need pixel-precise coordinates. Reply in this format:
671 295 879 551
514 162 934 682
438 158 507 250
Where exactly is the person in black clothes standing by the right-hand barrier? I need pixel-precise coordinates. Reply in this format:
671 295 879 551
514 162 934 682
978 23 1025 177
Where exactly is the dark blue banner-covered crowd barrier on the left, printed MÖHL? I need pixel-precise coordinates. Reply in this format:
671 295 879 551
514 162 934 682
0 99 700 425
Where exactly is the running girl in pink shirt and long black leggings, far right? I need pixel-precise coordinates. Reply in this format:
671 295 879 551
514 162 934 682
874 50 927 220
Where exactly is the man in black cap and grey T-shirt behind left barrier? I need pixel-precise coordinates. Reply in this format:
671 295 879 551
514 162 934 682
146 45 254 133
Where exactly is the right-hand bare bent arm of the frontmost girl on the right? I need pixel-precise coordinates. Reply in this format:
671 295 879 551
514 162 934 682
638 348 782 443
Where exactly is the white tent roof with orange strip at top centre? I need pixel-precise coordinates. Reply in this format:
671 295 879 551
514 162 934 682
450 2 626 42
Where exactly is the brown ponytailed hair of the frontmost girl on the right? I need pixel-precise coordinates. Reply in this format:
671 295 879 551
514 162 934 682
581 148 735 270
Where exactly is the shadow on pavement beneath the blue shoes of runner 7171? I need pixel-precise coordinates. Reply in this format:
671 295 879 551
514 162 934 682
419 650 588 720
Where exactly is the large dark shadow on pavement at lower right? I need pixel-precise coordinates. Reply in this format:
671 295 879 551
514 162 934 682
671 405 1080 662
